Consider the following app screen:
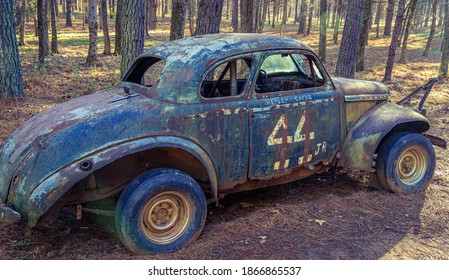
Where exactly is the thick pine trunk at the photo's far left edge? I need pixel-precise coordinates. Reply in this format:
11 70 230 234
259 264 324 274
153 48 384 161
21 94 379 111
0 0 23 99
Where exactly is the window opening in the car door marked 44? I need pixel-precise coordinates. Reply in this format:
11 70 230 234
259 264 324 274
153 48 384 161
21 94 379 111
256 53 325 93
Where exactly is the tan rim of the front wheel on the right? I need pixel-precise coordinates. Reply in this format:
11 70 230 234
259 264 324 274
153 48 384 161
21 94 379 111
396 146 428 186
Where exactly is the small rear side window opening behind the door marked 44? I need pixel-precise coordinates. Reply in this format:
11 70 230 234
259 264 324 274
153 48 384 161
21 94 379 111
200 58 252 98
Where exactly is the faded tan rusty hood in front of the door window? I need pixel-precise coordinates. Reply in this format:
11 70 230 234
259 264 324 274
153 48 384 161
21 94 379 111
332 78 390 99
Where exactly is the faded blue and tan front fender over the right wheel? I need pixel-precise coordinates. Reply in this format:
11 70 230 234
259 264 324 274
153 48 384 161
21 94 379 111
338 102 430 171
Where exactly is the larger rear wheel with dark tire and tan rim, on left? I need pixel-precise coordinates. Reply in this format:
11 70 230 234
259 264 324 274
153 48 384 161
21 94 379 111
115 168 207 254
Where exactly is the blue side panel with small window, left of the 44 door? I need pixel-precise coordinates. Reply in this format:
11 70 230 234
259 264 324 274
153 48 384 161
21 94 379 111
194 53 255 190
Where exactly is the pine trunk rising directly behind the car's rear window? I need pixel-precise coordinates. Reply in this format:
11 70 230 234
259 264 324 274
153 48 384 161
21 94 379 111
120 0 145 77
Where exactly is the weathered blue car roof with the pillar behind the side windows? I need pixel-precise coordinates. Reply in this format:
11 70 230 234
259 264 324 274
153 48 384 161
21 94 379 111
130 33 311 103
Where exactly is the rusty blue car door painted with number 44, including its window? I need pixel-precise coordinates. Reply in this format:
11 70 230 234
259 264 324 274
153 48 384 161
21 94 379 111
249 50 340 179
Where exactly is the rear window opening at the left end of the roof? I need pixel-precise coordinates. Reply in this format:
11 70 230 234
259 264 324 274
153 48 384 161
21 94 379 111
124 57 165 87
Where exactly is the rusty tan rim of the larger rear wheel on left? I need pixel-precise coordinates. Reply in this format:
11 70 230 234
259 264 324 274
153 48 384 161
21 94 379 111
140 192 192 244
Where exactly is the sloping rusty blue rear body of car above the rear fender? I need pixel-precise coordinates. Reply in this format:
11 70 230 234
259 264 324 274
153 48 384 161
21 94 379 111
0 87 158 202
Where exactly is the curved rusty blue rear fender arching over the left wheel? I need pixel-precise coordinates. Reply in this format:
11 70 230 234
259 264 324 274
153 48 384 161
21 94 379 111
26 136 218 226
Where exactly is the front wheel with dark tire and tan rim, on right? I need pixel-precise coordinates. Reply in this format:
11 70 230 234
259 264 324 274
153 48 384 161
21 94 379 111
376 132 436 193
